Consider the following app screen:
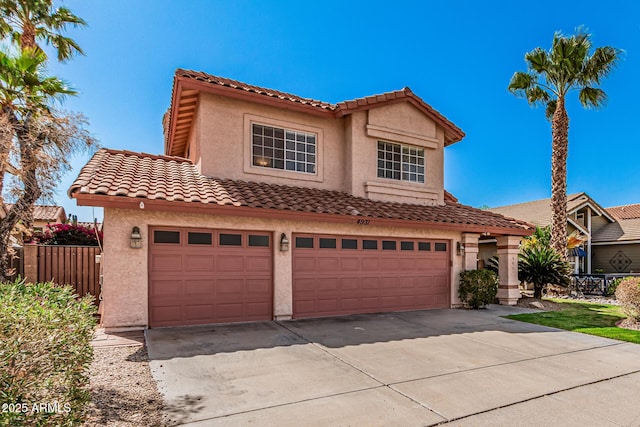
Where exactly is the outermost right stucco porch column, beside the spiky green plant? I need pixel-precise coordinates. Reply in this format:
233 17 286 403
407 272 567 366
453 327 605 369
498 236 520 305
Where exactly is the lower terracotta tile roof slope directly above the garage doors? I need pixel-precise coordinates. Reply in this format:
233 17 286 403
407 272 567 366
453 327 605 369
69 149 530 232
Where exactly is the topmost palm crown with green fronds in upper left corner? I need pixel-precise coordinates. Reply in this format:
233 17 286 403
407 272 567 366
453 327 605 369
0 0 87 61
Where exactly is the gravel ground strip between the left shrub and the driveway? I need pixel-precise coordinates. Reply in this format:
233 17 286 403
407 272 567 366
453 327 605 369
85 346 163 427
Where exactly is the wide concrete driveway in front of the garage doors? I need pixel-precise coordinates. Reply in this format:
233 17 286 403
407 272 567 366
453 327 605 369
146 306 640 426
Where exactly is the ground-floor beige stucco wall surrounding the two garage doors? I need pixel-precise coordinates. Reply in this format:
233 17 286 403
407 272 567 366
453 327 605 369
102 208 464 329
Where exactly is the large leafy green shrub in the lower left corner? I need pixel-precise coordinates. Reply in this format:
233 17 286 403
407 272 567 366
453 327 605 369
0 280 95 426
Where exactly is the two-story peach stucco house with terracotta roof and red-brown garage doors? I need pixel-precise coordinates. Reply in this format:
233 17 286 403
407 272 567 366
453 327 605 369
69 70 532 329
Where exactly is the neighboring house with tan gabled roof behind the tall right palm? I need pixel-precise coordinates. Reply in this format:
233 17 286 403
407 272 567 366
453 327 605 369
488 193 640 274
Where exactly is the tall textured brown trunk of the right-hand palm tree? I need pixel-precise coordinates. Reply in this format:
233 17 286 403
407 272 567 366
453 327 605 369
551 97 569 261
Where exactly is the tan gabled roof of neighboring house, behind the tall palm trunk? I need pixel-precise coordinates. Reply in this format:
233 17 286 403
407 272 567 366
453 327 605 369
488 193 613 227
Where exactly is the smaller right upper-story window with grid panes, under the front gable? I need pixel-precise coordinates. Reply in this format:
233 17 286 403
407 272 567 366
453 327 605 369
378 141 424 183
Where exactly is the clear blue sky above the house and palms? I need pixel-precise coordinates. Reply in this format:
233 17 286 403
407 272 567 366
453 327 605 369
50 0 640 220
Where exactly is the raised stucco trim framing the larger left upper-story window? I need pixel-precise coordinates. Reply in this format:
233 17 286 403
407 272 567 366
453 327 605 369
243 114 324 182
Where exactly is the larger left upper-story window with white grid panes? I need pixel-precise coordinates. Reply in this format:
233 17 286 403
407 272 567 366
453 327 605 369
251 123 317 174
